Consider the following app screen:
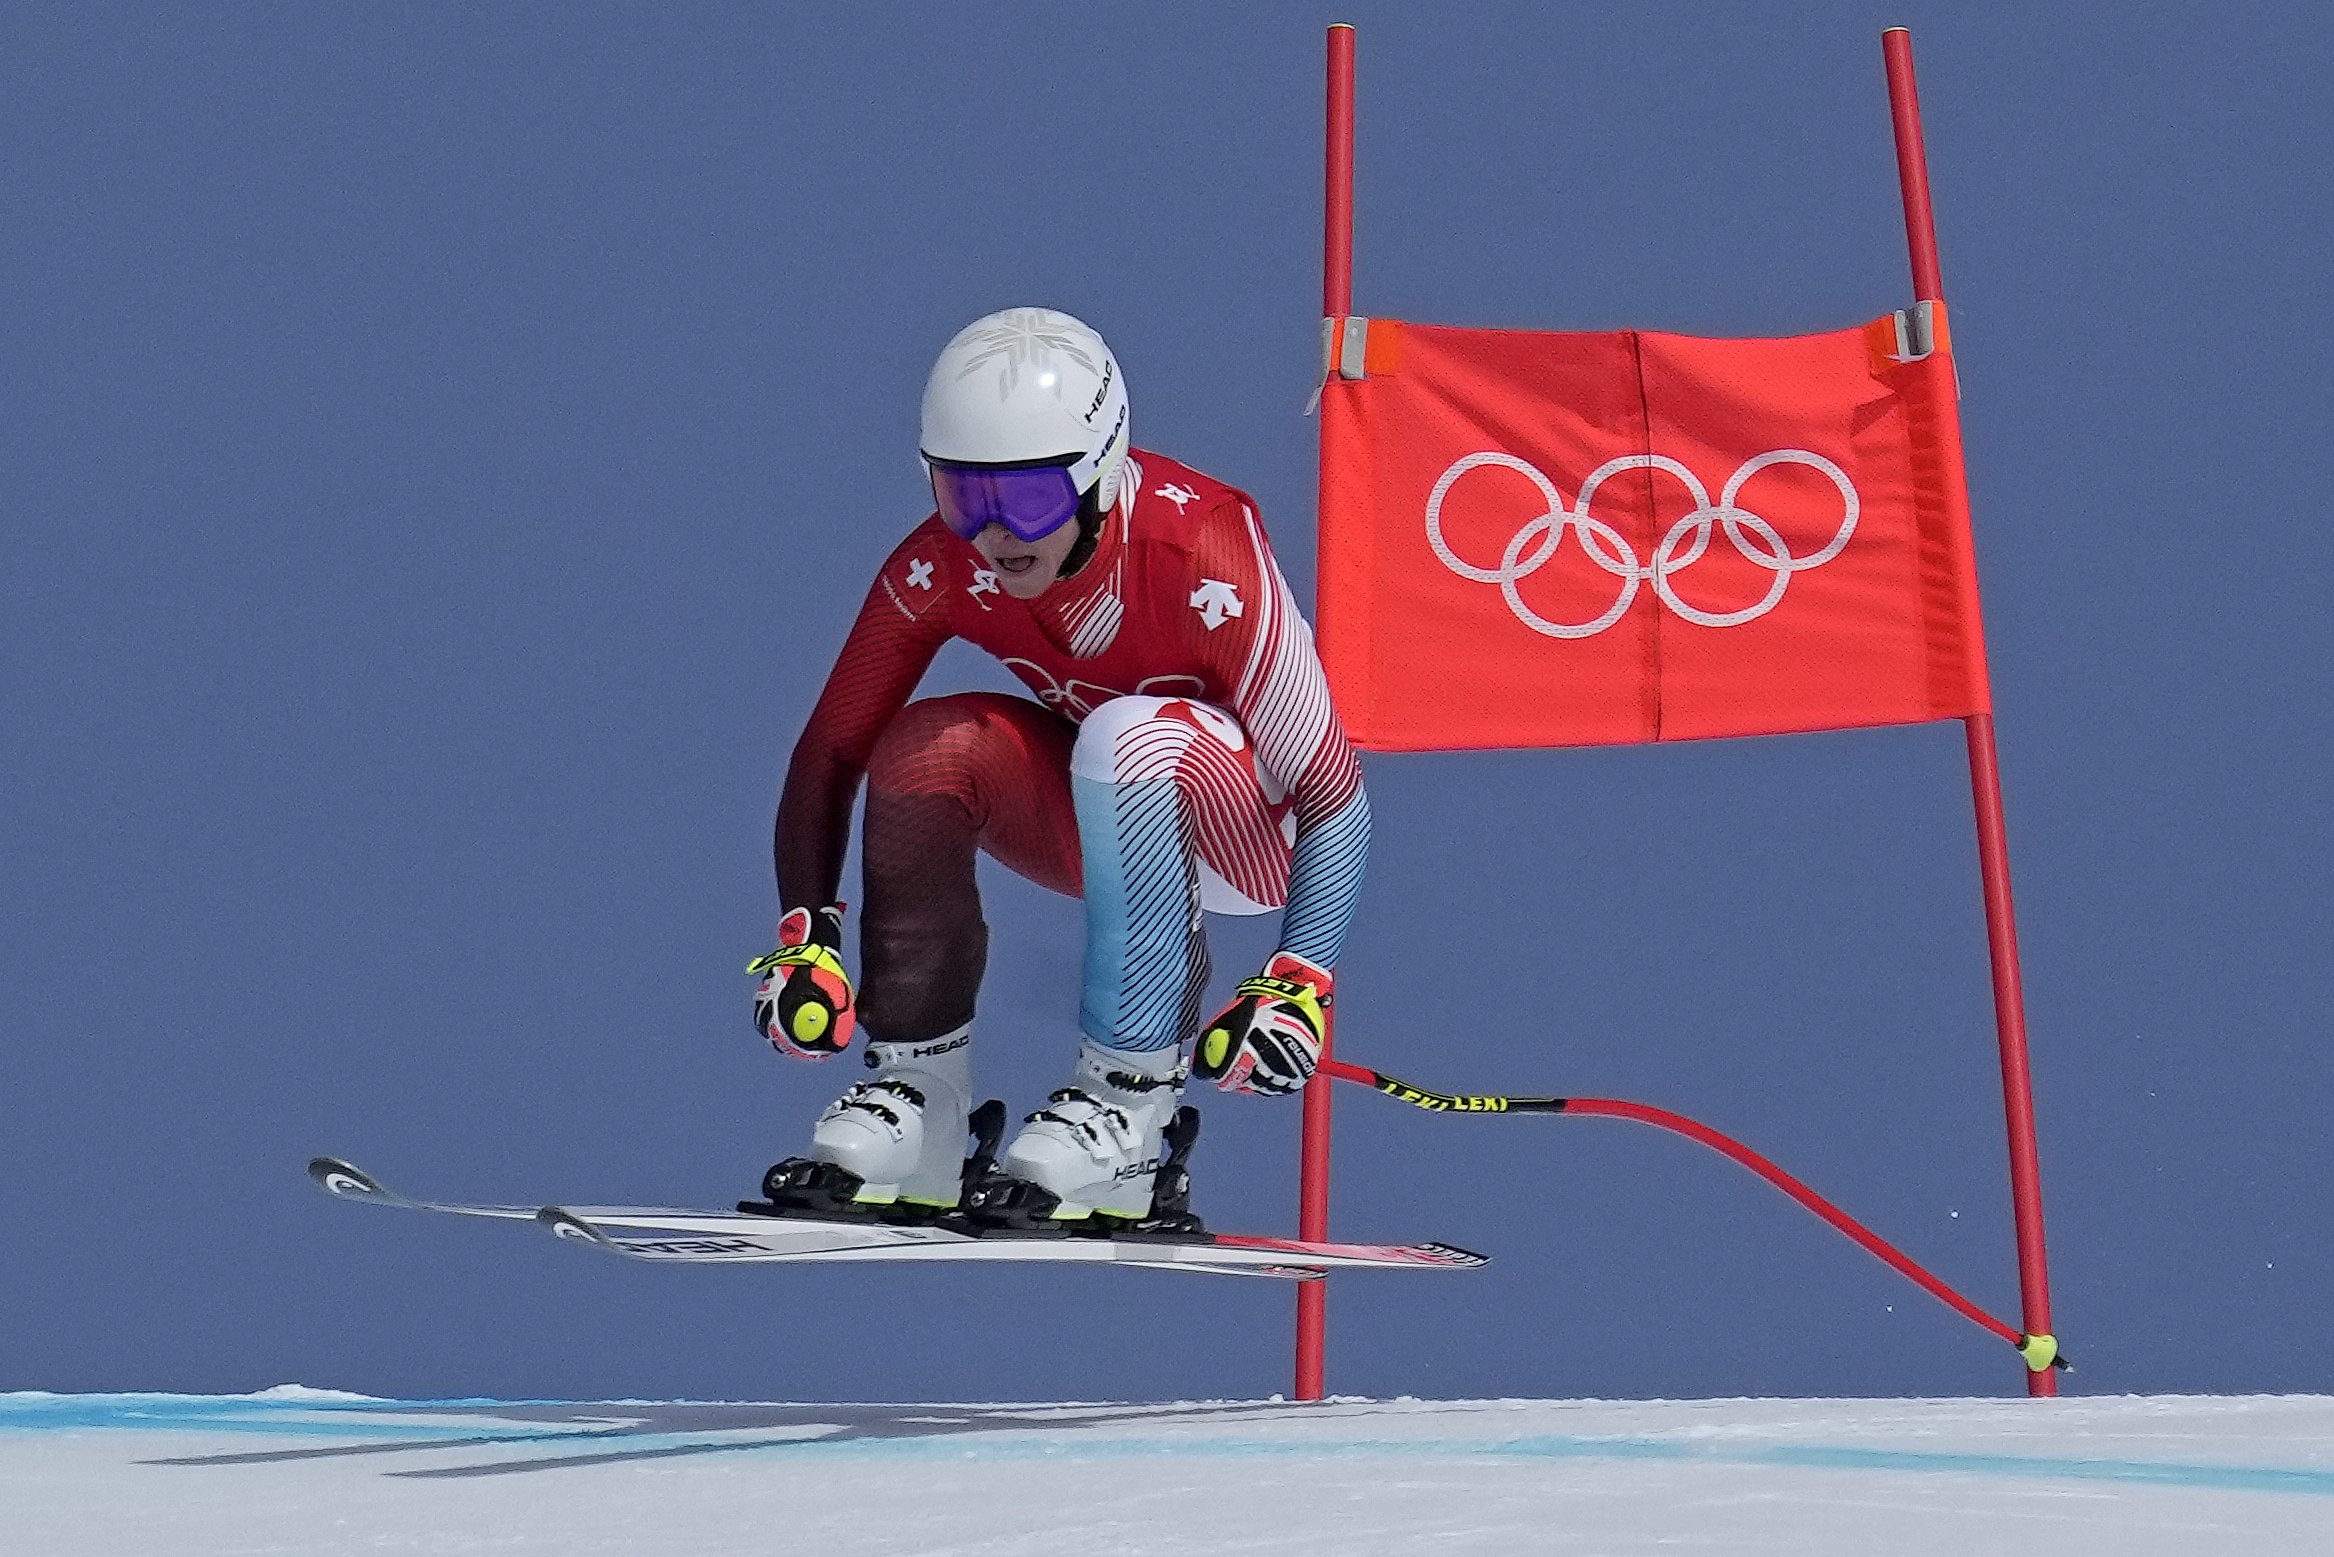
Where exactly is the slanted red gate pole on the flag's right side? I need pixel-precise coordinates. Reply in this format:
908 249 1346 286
1881 28 2059 1396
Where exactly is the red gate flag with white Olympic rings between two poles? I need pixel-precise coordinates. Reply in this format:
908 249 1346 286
1321 303 1989 752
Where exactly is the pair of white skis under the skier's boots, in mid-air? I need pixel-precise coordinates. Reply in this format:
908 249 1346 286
308 1158 1487 1282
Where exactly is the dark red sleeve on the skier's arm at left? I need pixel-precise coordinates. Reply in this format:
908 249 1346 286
773 521 957 908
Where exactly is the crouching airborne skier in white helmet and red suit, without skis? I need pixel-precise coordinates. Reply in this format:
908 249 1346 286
749 308 1370 1230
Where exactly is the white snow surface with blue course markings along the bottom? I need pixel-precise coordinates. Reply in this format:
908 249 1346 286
0 1387 2334 1557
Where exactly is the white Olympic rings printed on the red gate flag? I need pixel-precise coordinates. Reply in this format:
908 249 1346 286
1426 448 1863 637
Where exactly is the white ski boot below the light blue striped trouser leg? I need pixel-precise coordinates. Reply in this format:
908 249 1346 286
966 1041 1197 1230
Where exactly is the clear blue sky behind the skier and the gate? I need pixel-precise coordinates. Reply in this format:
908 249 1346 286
0 0 2334 1398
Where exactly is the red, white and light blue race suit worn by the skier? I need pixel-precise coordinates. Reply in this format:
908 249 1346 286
777 451 1368 1048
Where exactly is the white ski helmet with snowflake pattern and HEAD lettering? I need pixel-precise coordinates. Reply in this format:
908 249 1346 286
924 308 1127 511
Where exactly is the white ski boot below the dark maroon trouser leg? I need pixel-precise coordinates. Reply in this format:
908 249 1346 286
761 1027 973 1221
